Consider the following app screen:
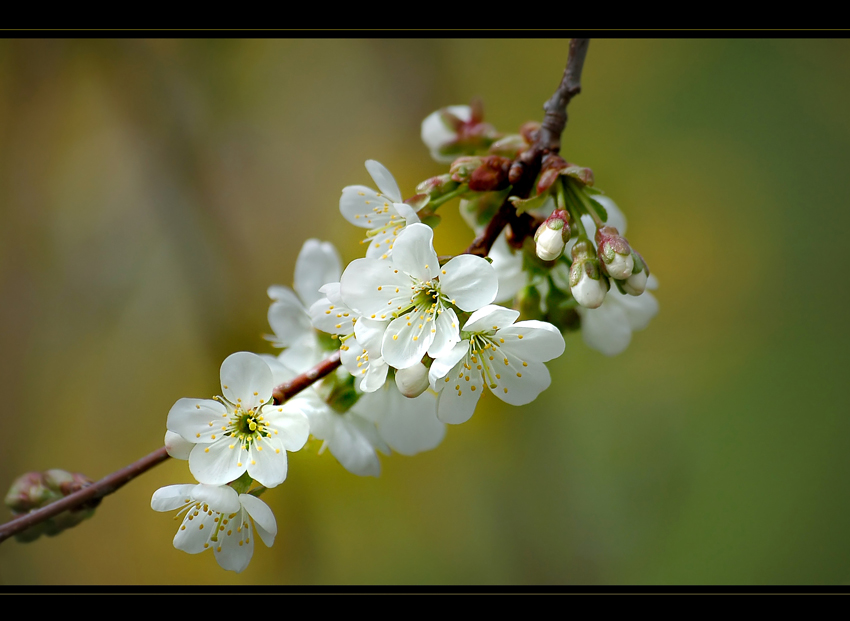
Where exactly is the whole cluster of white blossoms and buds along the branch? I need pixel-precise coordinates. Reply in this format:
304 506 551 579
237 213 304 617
151 101 657 572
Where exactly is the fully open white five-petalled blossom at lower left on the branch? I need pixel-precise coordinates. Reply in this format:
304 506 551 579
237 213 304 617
167 352 309 487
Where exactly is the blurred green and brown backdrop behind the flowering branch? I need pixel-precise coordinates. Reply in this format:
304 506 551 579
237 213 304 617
0 40 850 585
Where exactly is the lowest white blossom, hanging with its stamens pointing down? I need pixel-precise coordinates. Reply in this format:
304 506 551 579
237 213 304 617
151 484 277 573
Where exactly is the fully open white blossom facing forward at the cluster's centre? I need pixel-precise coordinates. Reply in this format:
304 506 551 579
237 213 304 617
340 224 498 369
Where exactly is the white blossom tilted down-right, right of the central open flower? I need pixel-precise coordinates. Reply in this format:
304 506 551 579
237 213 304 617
429 305 564 424
